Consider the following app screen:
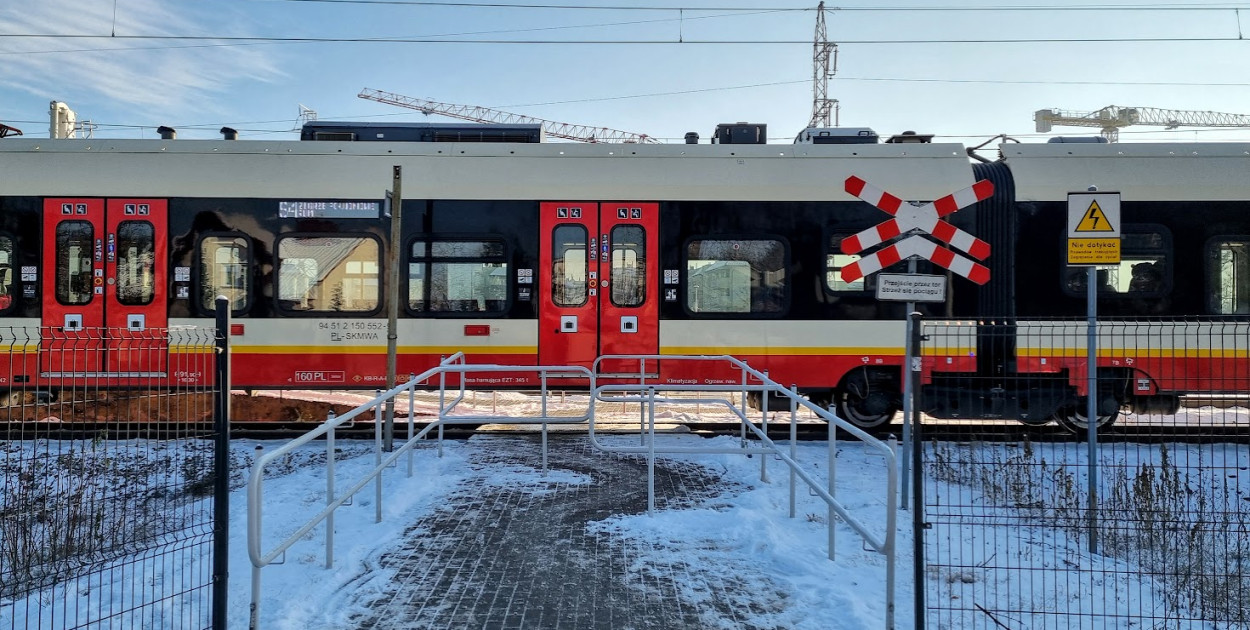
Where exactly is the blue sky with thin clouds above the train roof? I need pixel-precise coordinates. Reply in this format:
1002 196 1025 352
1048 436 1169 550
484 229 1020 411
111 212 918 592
0 0 1250 144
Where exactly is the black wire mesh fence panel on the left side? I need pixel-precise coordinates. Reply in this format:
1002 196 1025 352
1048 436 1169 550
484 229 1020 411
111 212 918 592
0 328 229 629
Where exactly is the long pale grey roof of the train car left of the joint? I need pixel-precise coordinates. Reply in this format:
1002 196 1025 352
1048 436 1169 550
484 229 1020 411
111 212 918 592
0 139 973 201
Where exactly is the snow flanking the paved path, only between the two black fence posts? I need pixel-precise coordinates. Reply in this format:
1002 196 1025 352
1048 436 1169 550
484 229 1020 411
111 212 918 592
230 435 911 630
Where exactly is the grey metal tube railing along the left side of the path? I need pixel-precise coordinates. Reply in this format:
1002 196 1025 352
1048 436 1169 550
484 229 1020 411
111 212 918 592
248 353 591 630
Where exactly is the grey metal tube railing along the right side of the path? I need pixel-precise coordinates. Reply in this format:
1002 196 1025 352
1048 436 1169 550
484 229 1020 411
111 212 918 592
589 355 899 629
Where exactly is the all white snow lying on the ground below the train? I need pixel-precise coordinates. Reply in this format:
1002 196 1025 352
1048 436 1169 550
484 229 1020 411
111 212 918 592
0 425 1250 630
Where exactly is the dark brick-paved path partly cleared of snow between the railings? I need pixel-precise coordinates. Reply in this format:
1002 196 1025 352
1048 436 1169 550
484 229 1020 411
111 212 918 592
354 434 785 630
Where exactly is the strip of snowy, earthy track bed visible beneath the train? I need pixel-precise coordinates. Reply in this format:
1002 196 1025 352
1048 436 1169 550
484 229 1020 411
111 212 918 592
0 390 1250 443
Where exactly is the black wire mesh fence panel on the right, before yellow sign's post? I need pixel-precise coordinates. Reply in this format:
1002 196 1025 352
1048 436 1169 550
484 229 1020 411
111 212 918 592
916 319 1250 629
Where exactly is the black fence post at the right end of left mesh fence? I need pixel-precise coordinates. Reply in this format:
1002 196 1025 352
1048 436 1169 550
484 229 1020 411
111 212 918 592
213 295 230 630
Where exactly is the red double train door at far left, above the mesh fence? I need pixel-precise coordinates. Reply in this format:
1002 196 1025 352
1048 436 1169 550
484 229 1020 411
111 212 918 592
40 199 169 378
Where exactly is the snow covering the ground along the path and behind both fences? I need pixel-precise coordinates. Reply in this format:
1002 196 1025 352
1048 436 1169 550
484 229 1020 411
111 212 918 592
0 427 1250 630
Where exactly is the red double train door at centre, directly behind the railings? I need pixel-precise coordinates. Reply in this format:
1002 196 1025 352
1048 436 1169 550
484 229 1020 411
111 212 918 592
539 203 660 373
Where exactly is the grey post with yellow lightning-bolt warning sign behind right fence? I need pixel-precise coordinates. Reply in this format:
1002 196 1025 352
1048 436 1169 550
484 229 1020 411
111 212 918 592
1068 186 1120 554
